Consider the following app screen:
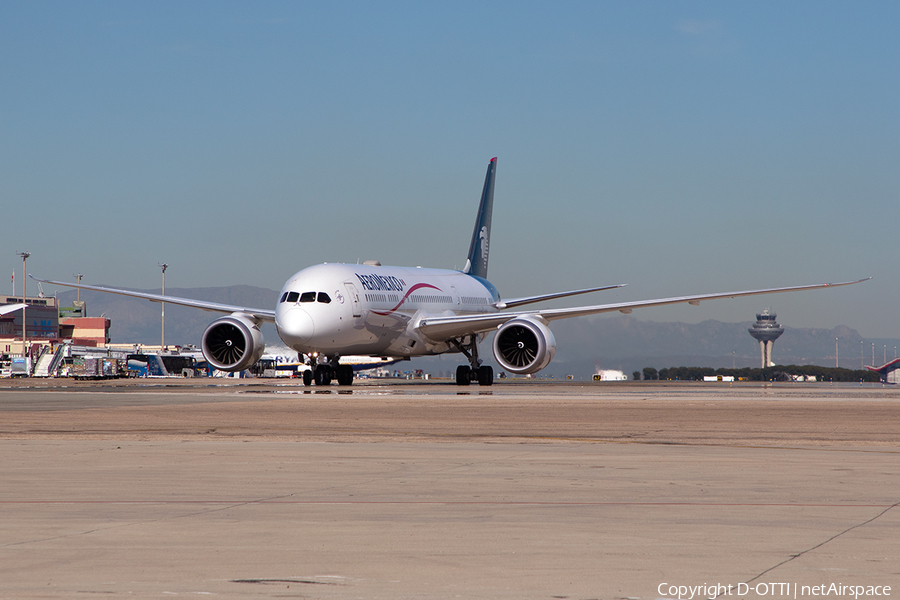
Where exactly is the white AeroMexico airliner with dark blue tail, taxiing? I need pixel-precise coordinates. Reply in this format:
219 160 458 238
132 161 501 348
31 158 866 385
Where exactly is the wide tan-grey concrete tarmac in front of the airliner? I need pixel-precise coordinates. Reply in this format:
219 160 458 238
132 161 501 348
0 382 900 600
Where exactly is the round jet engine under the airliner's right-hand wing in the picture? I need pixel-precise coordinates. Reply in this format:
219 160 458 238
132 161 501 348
494 317 556 374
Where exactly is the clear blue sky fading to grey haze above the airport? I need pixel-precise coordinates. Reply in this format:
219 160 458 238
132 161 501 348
0 1 900 337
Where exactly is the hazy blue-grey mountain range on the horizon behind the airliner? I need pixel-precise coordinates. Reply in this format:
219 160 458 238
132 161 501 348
59 285 900 379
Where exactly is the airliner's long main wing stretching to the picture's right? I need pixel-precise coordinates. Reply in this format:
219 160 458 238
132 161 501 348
416 277 871 342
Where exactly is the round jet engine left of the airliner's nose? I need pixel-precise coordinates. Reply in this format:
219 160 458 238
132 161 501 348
201 314 266 371
